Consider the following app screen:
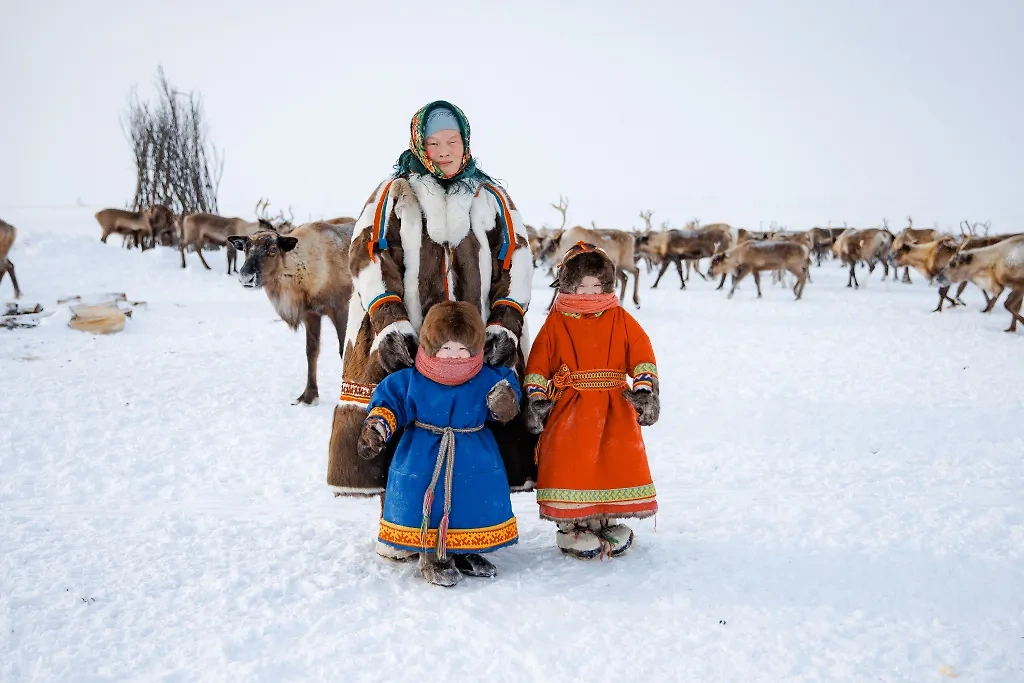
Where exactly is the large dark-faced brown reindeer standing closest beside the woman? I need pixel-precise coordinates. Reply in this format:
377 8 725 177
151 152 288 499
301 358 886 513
227 222 352 403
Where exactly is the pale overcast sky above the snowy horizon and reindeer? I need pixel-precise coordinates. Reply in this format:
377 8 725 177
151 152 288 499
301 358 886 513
0 0 1024 231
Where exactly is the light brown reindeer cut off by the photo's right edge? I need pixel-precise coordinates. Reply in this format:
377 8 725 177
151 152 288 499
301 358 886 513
935 236 1024 332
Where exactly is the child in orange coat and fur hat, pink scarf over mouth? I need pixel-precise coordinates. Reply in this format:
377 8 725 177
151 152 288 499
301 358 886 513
523 242 660 559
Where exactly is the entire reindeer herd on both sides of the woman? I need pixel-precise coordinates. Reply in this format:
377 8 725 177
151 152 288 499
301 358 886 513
0 198 1024 403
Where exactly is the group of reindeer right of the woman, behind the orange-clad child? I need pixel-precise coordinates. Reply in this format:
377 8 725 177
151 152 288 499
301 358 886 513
527 198 1024 332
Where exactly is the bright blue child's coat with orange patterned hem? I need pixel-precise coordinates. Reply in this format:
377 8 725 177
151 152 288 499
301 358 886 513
368 366 520 554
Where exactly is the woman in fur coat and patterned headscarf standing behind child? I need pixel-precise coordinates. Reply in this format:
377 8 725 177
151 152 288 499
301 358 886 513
327 101 537 575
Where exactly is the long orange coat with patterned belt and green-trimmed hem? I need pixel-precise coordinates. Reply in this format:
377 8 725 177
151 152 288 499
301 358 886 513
523 306 657 521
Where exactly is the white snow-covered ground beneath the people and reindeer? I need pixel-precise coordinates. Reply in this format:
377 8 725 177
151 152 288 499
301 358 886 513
0 210 1024 682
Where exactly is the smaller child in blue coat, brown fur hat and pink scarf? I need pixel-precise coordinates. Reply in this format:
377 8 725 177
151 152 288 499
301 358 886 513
358 301 520 587
